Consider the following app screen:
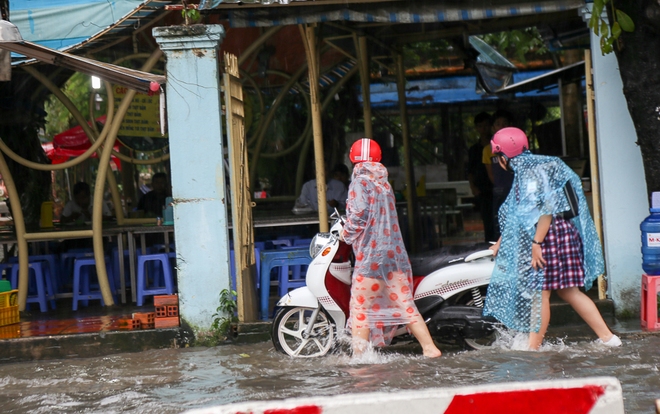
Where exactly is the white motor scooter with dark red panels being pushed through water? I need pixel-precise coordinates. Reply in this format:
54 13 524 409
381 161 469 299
271 213 497 357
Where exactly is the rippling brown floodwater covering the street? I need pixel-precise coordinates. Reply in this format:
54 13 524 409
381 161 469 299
0 335 660 414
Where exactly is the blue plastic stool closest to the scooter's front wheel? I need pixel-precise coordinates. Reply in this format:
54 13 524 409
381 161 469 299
260 247 312 320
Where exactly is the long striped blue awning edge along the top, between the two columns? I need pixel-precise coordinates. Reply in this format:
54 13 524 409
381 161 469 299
226 0 584 27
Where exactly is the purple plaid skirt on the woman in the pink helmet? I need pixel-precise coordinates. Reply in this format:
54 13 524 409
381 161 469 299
541 216 584 290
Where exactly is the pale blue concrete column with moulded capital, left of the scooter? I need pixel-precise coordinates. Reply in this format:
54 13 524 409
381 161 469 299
153 25 230 333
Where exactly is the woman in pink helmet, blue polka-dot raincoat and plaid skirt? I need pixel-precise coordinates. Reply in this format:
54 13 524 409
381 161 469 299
484 128 621 349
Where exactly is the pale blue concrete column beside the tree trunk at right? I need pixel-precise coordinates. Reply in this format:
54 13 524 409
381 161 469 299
584 5 649 315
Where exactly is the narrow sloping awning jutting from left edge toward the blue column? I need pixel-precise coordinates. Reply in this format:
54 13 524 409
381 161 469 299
0 20 165 93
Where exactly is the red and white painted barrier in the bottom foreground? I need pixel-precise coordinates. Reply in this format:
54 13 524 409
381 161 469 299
188 377 624 414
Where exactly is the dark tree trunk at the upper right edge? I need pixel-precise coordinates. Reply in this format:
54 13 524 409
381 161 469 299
608 0 660 194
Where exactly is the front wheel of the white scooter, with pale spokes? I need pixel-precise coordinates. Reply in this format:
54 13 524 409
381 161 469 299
271 306 335 358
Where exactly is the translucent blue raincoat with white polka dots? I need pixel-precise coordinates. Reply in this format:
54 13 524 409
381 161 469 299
484 151 604 332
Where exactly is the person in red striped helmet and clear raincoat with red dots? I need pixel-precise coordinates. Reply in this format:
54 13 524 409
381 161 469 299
342 138 441 357
